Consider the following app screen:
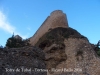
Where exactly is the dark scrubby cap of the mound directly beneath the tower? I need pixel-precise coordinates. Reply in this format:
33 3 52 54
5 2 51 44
36 27 86 49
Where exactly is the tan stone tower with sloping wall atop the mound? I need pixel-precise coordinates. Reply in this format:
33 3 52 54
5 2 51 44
30 10 68 45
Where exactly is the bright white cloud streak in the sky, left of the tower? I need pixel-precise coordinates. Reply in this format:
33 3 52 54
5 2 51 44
0 11 27 39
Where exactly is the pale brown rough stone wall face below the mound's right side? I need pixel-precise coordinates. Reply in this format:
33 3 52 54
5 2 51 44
61 38 100 75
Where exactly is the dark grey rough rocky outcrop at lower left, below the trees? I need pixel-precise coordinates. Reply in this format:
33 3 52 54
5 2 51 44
0 46 47 75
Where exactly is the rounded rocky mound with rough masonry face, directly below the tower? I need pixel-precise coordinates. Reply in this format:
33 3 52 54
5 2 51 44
36 27 100 75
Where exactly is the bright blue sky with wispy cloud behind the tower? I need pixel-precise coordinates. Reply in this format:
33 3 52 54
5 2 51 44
0 0 100 46
